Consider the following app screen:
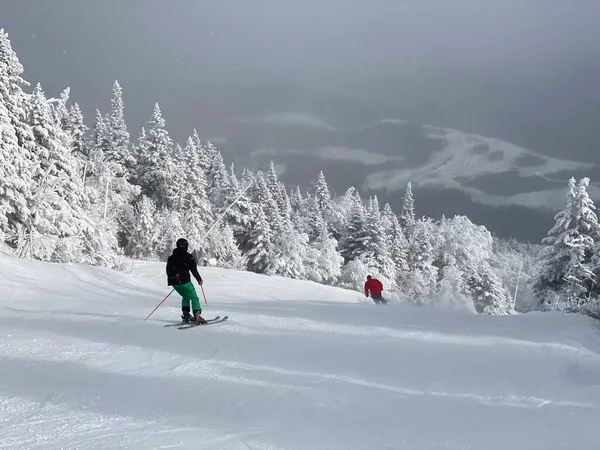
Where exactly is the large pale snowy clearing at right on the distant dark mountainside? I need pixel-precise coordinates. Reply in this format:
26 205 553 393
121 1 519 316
364 121 600 210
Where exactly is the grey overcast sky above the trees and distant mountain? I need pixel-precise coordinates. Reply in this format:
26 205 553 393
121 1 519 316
0 0 600 163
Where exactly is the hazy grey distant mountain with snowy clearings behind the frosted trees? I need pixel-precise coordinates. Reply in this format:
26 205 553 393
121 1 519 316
204 112 600 242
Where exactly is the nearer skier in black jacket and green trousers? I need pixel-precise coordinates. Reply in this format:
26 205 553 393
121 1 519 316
167 238 206 324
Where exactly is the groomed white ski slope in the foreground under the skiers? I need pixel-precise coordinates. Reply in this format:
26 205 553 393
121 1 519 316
0 257 600 450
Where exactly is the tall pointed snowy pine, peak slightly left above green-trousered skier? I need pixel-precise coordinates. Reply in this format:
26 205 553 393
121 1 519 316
136 103 176 210
